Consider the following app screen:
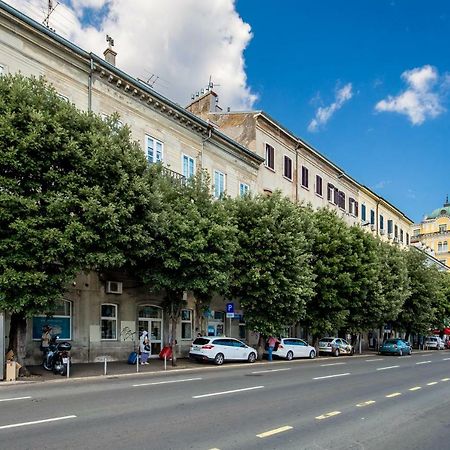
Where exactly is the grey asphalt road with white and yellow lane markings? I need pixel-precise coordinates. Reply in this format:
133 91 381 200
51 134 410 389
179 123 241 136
0 351 450 450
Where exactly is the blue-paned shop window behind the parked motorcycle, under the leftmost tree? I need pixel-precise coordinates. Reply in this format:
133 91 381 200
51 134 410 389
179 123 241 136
33 300 72 341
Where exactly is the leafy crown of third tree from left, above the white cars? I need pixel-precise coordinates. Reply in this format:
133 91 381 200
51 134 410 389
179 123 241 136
229 193 314 352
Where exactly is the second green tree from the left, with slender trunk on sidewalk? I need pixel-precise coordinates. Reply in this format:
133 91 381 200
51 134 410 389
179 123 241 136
139 166 236 365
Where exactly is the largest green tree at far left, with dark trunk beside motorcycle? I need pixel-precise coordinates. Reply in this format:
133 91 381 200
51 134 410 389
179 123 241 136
0 75 149 370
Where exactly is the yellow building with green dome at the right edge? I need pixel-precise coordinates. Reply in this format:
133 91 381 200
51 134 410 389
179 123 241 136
411 196 450 266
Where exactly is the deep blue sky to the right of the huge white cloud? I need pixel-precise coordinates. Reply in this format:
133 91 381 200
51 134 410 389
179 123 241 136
236 0 450 221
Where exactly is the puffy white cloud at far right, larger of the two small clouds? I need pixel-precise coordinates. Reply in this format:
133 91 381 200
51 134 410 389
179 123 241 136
375 65 445 125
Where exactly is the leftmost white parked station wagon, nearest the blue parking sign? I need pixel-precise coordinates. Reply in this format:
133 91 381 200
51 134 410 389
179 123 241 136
189 336 257 366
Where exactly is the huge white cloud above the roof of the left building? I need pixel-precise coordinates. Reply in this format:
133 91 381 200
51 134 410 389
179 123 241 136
7 0 257 109
